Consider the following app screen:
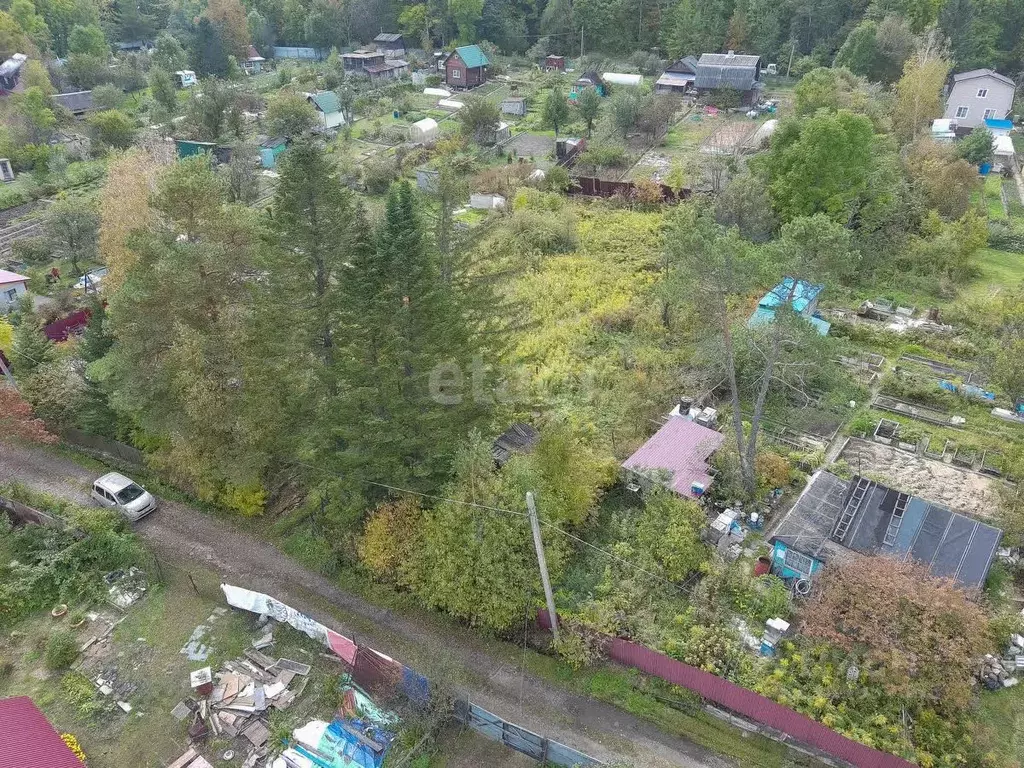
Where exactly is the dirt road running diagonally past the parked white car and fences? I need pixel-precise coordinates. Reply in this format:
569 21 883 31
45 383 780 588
0 441 740 768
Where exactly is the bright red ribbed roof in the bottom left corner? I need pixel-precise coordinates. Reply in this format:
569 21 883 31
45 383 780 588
0 696 85 768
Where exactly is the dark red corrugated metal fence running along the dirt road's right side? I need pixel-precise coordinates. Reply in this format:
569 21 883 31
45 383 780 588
538 611 915 768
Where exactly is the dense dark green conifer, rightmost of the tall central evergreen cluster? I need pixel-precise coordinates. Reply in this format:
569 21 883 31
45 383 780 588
336 181 486 488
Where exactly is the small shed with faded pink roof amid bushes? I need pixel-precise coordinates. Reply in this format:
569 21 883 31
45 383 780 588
623 414 725 499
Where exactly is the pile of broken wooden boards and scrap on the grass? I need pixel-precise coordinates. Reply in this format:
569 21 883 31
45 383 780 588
171 632 311 768
